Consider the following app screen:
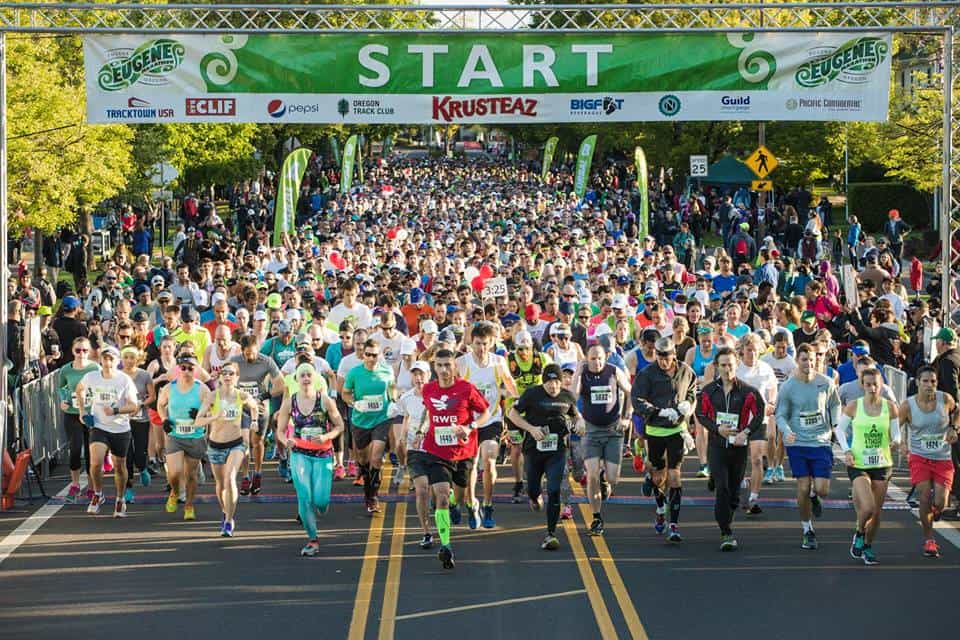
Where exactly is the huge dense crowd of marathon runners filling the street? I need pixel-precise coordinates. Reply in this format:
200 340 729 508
13 156 960 568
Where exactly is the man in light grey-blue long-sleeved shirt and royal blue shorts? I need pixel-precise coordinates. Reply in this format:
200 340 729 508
776 344 841 550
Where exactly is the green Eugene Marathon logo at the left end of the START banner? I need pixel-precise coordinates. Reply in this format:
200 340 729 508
97 38 186 91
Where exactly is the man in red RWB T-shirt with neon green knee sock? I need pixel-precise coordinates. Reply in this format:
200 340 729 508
421 349 490 569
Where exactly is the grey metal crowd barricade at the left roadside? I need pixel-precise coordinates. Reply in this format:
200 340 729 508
14 372 68 478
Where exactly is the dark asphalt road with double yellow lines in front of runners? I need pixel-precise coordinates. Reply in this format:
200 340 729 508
0 452 960 640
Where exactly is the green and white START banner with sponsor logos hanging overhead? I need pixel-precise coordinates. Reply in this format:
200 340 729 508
84 32 892 124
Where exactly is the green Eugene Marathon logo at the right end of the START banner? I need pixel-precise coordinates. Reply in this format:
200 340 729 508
794 36 890 89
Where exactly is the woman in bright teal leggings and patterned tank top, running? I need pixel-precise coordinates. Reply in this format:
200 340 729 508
277 363 343 556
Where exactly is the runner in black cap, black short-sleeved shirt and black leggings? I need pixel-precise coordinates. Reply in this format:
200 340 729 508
507 364 583 551
